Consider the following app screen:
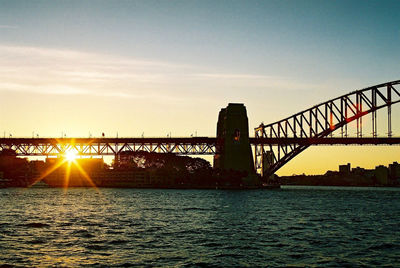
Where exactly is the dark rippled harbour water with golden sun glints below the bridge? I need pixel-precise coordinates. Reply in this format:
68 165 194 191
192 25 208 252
0 187 400 267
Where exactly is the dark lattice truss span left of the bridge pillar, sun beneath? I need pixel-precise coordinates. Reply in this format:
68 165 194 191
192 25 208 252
0 137 216 156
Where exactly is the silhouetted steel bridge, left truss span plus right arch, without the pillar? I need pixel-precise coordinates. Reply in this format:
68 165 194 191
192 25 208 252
0 80 400 176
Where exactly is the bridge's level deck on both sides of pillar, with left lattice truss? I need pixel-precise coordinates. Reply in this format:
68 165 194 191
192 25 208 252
0 137 400 156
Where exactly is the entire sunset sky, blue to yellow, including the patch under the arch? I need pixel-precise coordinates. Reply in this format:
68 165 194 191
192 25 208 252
0 0 400 175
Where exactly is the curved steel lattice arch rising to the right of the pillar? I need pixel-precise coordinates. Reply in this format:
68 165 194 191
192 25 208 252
254 80 400 178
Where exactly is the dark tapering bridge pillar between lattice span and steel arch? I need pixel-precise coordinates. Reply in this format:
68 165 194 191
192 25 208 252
214 103 255 176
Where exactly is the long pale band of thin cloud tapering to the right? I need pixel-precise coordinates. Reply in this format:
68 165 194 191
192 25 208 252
0 45 318 101
